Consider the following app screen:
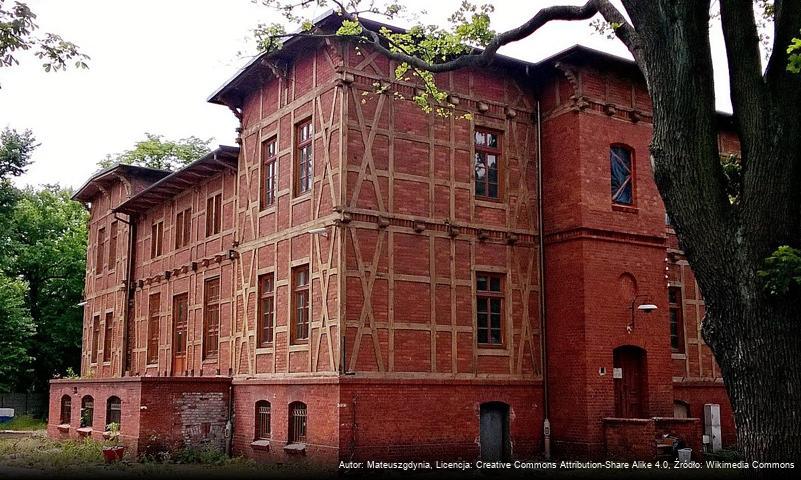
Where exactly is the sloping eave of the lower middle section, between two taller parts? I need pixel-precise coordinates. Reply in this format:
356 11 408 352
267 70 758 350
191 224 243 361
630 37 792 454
114 145 239 215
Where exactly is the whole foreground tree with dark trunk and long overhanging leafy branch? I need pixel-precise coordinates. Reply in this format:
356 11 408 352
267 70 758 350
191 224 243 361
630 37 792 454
256 0 801 461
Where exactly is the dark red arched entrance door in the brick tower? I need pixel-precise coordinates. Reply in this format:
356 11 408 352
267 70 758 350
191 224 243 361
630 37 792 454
613 345 648 418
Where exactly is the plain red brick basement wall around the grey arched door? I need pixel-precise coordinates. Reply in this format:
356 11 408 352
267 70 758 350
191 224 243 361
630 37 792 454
339 379 542 460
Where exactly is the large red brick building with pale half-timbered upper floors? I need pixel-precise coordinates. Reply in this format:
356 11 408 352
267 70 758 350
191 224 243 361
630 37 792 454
49 16 738 461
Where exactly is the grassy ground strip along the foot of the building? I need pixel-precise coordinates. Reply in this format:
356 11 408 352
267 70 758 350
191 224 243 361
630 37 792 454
0 432 743 480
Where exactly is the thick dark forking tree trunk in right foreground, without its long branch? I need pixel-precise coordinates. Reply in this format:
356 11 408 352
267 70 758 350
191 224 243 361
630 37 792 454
623 0 801 463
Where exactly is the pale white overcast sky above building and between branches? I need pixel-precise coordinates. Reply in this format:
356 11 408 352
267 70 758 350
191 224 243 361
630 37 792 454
0 0 730 187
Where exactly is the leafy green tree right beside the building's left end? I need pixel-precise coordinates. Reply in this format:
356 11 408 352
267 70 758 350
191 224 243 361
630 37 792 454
0 186 87 391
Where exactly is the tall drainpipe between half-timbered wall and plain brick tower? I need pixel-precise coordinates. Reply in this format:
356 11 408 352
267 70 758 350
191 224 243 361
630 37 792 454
537 100 551 458
